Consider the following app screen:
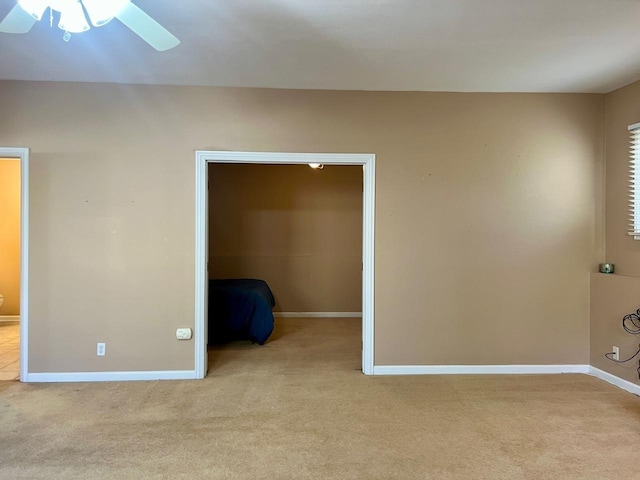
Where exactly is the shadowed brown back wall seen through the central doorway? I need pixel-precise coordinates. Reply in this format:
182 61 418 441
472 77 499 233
209 164 362 312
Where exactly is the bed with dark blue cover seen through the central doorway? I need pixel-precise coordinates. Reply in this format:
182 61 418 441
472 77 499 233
209 278 276 345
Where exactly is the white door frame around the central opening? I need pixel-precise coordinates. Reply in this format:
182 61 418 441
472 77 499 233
194 151 376 378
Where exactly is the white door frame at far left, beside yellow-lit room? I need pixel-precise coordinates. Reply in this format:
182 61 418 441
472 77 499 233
0 147 29 382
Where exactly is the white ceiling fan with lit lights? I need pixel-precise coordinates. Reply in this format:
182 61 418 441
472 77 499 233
0 0 180 52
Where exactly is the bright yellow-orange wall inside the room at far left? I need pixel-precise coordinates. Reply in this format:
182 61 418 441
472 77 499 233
0 158 20 315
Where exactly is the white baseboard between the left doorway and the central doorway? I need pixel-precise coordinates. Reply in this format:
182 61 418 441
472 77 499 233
23 370 196 383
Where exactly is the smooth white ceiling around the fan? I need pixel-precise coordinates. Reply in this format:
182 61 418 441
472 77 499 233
0 0 640 93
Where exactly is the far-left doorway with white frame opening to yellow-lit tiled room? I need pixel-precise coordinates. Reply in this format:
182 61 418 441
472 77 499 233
0 147 29 382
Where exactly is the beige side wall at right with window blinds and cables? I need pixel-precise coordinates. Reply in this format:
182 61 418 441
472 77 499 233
591 82 640 383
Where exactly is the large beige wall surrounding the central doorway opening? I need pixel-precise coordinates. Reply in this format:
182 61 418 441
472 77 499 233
0 81 604 372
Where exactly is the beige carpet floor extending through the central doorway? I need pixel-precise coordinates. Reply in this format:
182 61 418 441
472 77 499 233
0 319 640 480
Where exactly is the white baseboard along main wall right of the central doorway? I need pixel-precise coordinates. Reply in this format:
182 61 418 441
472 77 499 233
373 365 589 375
